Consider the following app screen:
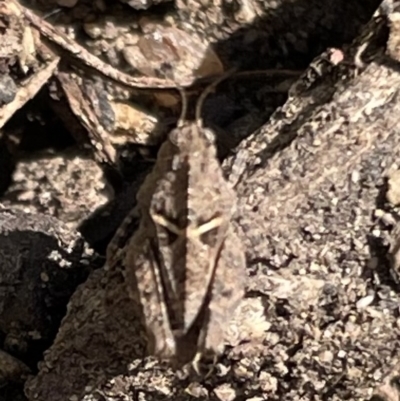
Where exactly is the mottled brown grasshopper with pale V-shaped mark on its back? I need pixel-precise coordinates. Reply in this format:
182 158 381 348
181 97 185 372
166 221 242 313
108 79 246 364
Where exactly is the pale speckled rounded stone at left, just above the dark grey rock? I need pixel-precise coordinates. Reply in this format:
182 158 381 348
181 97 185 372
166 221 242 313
3 151 113 229
